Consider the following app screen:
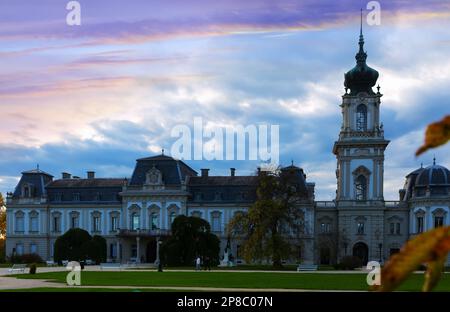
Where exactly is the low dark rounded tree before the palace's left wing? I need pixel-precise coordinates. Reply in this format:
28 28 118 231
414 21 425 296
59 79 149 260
54 228 106 263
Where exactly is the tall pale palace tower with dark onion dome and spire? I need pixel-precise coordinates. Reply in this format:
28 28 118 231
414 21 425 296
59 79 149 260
333 15 389 262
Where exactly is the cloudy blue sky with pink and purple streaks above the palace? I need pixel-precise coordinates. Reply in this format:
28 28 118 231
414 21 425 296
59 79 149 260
0 0 450 200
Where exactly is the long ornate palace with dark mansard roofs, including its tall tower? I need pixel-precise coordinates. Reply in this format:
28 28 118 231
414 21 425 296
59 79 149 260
6 26 450 264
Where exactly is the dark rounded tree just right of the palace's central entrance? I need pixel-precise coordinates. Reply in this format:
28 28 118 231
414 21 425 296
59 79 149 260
161 215 220 265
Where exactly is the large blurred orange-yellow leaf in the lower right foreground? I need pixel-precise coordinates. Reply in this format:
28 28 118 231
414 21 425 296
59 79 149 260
376 226 450 291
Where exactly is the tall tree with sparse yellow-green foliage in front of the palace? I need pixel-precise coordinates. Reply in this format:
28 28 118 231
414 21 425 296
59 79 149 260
228 167 308 267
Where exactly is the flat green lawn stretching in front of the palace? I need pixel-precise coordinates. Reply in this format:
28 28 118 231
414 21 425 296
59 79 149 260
9 271 450 291
